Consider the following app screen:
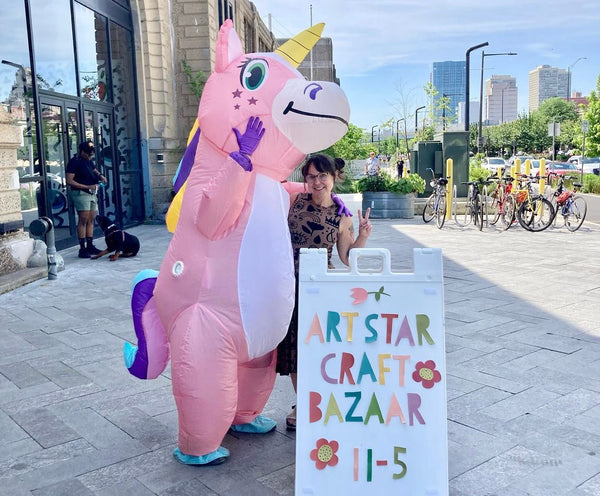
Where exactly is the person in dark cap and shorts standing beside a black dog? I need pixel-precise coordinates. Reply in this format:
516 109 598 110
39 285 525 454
66 141 106 258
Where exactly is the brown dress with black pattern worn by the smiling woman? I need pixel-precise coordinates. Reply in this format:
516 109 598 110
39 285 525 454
277 193 341 375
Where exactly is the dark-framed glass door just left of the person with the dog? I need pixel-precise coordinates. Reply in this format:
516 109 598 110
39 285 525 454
38 97 79 245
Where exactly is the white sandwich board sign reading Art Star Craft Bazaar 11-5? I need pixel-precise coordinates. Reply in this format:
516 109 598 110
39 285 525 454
296 248 448 496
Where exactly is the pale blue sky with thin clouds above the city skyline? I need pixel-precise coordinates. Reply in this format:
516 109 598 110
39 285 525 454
252 0 600 129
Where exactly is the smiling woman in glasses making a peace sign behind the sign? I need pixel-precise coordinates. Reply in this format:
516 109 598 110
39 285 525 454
276 154 371 430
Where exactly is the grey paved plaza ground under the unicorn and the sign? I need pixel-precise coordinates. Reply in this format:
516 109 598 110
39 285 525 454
0 195 600 496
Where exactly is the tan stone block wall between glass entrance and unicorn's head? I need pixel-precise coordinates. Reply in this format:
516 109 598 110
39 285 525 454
132 0 275 219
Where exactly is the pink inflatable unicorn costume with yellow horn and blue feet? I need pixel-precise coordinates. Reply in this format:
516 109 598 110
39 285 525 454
124 20 350 465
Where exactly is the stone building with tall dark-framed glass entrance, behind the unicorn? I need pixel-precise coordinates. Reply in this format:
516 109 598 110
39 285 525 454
0 0 275 277
